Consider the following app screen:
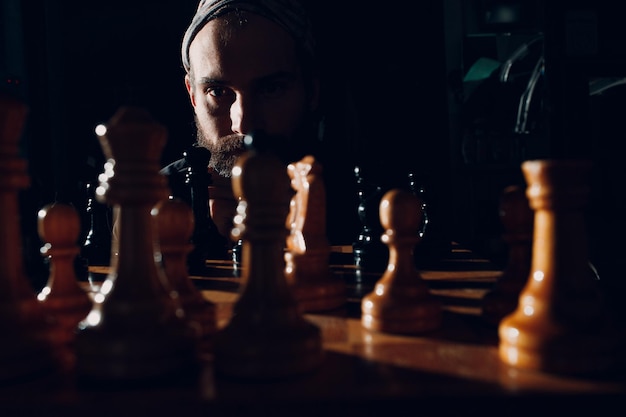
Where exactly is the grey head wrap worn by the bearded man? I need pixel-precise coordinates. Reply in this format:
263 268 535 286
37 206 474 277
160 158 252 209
181 0 314 72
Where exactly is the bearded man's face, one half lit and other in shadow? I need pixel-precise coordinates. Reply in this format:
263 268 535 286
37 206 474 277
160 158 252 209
185 14 316 176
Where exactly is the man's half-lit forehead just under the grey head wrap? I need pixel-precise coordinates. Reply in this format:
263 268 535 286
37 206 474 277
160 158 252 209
189 13 296 82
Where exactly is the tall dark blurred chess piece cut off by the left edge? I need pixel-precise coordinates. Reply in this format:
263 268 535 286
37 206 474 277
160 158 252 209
0 95 56 383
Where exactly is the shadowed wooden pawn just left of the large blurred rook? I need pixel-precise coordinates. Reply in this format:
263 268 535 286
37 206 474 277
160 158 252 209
482 185 533 326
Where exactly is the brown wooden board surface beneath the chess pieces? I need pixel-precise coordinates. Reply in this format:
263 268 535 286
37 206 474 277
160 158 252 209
0 245 626 417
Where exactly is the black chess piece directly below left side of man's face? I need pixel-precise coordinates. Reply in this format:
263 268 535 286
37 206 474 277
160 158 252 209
185 146 229 275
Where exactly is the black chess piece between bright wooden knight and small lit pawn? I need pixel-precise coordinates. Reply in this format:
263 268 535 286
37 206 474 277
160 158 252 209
352 166 389 272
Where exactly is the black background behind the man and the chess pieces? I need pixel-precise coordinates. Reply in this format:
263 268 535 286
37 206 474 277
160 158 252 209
0 0 626 318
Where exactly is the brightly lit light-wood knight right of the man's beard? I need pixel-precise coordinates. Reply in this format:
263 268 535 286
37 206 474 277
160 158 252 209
285 155 347 312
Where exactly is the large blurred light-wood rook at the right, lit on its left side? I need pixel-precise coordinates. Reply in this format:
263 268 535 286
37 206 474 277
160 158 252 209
498 160 623 374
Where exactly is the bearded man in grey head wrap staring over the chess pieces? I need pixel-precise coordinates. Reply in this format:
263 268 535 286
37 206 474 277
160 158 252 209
162 0 319 256
